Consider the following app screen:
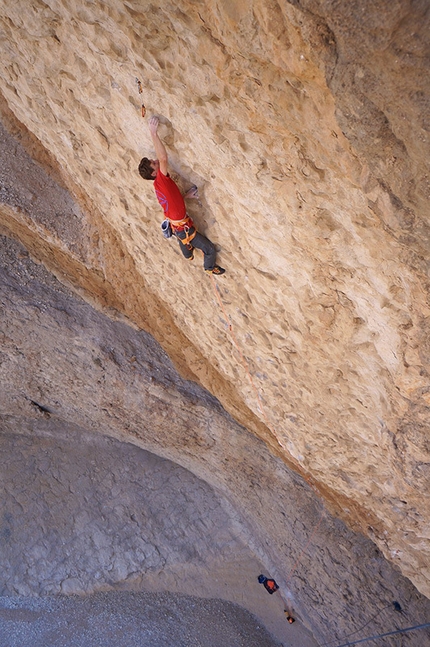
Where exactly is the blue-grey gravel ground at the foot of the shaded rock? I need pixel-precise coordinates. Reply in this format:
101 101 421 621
0 592 280 647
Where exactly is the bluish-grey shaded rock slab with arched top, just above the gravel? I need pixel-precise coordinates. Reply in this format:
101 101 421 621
1 419 263 595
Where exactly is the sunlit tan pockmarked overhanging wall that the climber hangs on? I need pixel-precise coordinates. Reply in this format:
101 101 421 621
0 0 430 595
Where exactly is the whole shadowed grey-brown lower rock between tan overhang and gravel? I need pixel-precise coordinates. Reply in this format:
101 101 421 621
0 238 430 647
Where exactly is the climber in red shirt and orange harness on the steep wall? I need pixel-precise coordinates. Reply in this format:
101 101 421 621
139 117 225 275
